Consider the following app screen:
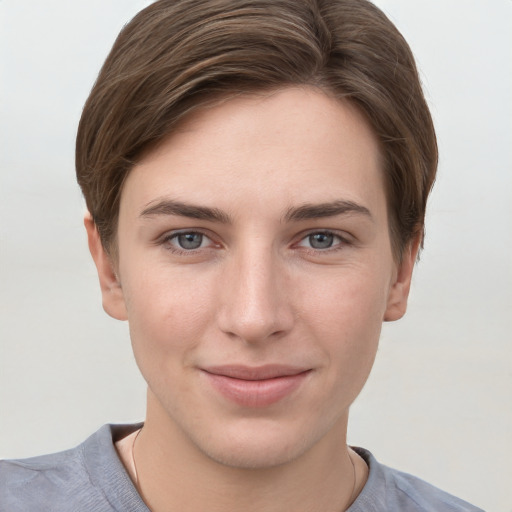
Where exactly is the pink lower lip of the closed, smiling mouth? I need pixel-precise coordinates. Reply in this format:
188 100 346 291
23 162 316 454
203 371 310 407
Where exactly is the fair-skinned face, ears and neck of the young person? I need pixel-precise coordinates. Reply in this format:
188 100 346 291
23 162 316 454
85 88 418 512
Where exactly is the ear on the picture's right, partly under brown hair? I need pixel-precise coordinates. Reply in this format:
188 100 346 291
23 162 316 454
384 234 422 322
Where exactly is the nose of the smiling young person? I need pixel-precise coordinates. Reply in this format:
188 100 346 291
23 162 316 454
218 246 294 343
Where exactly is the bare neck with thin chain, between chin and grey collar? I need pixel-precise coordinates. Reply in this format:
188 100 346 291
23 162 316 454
133 392 366 512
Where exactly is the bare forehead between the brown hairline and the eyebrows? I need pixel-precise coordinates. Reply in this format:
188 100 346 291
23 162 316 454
121 88 384 218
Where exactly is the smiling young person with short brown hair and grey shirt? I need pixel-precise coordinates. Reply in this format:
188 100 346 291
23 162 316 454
0 0 484 512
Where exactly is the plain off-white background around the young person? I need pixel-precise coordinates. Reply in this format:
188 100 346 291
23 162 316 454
0 0 512 512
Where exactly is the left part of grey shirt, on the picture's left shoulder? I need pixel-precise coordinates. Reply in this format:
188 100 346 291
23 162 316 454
0 425 148 512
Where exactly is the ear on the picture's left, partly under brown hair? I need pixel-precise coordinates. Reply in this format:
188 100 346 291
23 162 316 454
84 212 128 320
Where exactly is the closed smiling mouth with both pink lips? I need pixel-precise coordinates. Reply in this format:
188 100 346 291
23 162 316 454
202 365 312 408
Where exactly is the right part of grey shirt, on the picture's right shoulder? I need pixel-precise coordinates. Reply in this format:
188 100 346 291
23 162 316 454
348 448 484 512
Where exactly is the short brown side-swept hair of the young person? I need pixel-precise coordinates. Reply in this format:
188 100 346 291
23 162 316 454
76 0 437 258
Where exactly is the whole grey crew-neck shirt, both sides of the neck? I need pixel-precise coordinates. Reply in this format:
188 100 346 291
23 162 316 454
0 424 482 512
